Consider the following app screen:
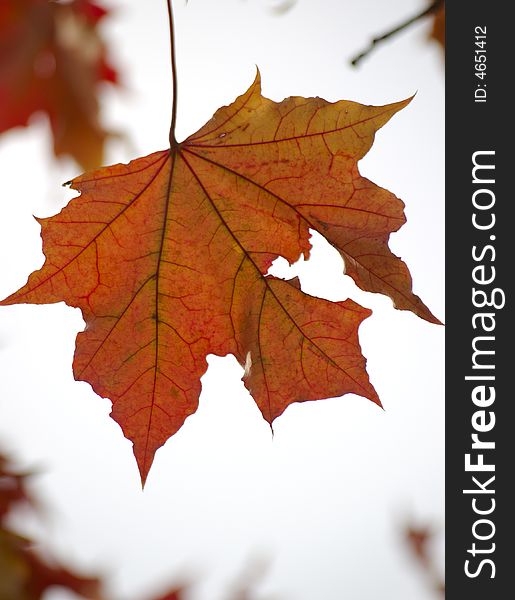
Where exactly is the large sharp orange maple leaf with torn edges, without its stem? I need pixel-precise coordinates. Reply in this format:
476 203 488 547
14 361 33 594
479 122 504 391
3 75 437 480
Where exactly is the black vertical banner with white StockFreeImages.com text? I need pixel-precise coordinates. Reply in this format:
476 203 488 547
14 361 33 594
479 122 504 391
446 0 515 600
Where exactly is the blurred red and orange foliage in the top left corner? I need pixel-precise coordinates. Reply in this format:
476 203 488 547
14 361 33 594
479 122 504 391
0 0 116 169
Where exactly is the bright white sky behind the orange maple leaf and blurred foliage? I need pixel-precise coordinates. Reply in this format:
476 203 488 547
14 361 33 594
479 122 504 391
0 0 444 600
